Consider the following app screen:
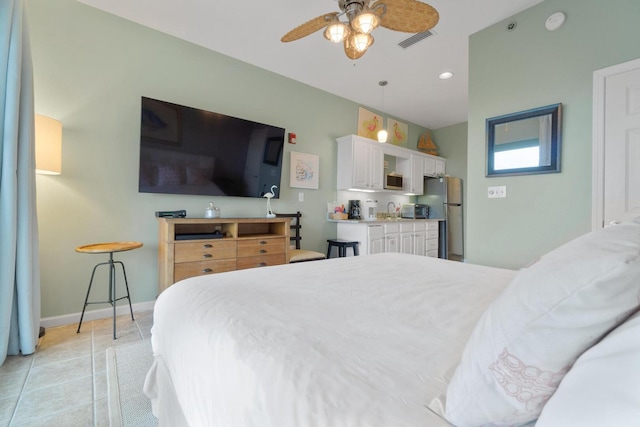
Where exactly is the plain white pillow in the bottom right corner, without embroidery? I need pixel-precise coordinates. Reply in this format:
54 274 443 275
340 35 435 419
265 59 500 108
536 314 640 427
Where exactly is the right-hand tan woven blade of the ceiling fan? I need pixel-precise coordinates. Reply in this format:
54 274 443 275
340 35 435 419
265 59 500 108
376 0 440 33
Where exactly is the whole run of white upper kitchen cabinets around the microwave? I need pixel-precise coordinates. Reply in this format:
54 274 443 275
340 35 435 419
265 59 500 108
337 135 445 195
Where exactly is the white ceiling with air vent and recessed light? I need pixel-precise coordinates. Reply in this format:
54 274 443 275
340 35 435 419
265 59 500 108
80 0 542 129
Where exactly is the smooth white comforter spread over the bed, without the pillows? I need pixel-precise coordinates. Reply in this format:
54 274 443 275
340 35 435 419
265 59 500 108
145 254 515 427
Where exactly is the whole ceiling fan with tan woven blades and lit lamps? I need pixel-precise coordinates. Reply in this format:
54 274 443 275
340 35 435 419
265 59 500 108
280 0 440 59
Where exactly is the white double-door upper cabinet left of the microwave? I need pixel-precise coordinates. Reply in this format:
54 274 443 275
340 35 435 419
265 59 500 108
338 135 384 191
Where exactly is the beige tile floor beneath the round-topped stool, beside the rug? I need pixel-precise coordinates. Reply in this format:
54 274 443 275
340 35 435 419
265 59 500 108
0 311 153 427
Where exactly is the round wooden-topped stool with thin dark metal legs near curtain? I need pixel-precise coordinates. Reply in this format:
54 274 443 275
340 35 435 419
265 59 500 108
76 242 142 340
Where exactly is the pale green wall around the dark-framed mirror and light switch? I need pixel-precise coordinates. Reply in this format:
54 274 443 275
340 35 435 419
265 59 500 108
466 0 640 268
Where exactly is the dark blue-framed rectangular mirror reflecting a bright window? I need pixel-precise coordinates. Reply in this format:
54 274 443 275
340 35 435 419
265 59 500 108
487 104 562 177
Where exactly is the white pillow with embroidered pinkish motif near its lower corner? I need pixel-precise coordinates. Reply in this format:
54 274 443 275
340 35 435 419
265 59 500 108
445 218 640 427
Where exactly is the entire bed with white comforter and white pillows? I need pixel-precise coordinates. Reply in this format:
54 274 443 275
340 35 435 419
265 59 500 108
145 218 640 427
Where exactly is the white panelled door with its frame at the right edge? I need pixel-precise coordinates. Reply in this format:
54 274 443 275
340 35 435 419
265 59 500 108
593 60 640 228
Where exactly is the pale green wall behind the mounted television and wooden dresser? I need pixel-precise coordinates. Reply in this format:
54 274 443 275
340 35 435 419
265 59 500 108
27 0 424 317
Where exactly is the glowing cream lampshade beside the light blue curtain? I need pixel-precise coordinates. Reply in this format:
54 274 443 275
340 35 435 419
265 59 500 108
36 114 62 175
